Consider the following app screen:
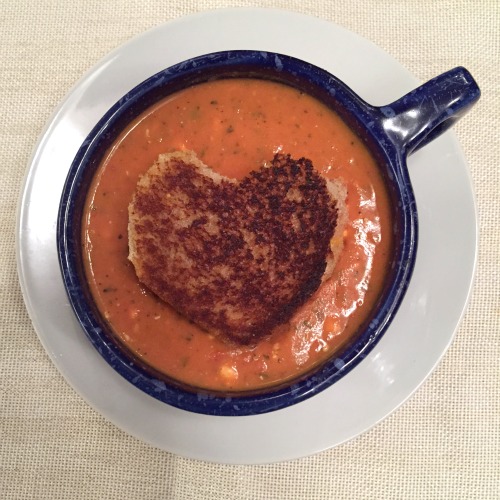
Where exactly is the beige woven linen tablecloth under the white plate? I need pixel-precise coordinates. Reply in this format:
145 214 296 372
0 0 500 500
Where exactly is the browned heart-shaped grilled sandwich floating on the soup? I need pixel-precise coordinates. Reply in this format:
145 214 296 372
129 151 346 344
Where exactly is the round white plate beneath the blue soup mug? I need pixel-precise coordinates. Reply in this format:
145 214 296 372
17 8 477 464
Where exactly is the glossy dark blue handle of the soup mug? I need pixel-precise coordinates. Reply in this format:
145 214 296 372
378 66 481 155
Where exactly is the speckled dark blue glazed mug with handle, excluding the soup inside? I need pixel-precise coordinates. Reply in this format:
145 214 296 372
57 51 480 416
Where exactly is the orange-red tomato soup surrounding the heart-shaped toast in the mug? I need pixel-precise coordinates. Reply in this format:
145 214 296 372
82 78 392 392
